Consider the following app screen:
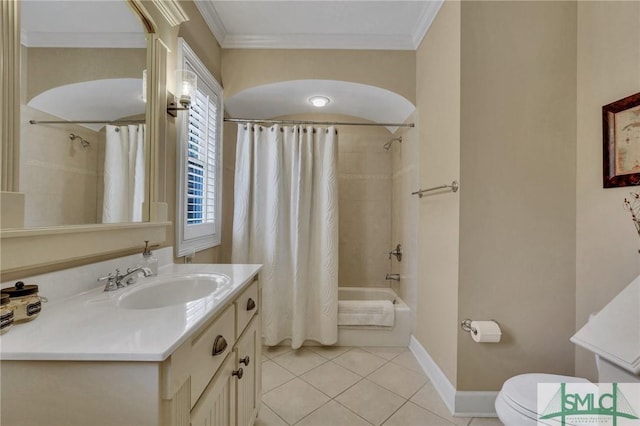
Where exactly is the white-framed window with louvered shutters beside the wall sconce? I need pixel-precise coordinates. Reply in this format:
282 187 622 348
176 39 223 256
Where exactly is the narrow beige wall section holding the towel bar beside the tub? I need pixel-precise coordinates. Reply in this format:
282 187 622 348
413 2 465 384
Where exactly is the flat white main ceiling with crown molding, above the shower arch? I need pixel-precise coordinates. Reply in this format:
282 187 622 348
196 0 442 50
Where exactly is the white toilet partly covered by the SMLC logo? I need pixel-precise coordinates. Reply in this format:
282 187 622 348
495 277 640 426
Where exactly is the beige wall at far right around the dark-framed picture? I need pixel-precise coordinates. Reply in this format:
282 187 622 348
576 1 640 380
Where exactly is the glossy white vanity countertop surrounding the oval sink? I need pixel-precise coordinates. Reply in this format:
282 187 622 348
0 264 261 361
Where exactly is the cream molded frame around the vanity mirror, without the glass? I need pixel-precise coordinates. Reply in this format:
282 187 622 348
0 0 189 281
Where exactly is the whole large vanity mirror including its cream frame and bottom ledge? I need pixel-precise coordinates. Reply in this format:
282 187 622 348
0 0 188 280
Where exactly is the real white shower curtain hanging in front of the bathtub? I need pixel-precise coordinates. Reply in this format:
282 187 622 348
232 124 338 349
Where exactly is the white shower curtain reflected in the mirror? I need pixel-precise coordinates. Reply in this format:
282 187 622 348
102 124 145 223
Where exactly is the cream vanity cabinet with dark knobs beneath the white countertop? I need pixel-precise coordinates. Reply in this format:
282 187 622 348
0 273 262 426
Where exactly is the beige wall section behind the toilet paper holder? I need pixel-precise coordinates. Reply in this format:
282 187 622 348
456 2 576 390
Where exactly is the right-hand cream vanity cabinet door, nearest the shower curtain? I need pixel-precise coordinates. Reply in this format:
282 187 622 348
236 316 262 426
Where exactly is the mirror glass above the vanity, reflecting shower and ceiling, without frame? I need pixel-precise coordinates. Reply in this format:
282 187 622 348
18 0 149 228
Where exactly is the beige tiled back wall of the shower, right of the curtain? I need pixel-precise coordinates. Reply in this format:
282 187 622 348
338 126 392 287
